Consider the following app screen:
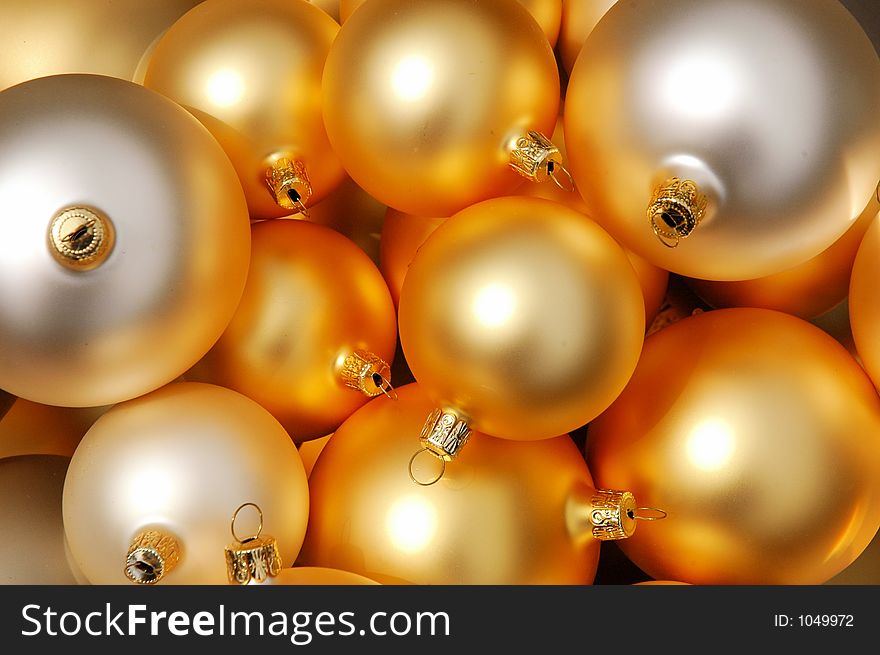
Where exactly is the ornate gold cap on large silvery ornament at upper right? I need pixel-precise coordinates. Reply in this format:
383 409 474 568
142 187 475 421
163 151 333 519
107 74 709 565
648 177 709 248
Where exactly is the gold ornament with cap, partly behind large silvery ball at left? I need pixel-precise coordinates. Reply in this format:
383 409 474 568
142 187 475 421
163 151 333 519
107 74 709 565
144 0 344 218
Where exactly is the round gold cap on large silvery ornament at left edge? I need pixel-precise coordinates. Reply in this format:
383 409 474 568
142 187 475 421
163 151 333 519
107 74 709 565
49 207 116 271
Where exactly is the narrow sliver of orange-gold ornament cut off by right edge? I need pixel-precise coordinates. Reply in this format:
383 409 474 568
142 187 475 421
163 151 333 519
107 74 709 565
849 216 880 389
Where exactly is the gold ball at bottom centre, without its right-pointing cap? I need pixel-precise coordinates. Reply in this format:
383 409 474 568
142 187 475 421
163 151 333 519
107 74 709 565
300 385 600 584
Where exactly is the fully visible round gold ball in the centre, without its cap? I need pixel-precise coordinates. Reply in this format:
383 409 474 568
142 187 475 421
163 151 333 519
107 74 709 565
399 196 645 439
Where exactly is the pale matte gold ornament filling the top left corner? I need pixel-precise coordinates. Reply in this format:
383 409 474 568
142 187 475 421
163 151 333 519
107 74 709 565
0 0 200 90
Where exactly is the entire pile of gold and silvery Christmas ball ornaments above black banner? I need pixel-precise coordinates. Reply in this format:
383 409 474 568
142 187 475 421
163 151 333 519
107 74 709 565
0 0 880 584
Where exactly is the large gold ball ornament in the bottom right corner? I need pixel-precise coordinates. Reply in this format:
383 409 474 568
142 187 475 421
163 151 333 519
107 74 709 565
587 309 880 584
